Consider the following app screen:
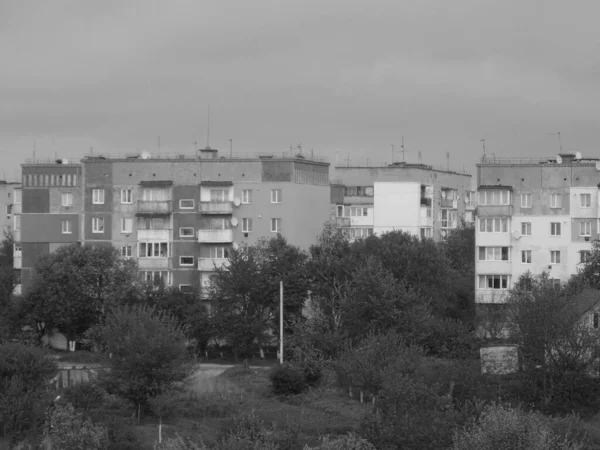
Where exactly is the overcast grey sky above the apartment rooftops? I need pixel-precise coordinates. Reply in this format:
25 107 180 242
0 0 600 178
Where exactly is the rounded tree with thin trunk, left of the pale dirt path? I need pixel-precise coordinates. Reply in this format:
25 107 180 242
95 305 189 407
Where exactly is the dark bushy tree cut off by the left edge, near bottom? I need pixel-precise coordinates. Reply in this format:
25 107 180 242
0 344 57 439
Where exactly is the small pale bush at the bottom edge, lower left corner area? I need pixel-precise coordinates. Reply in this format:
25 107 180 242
48 403 108 450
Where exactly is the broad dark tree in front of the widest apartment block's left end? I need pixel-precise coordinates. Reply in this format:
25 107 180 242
25 245 138 340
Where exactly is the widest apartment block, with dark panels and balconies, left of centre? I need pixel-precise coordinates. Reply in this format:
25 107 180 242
20 148 331 290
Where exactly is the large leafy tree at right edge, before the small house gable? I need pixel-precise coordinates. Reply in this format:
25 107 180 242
507 273 600 411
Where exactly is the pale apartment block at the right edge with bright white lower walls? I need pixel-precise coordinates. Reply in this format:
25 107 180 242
476 154 600 304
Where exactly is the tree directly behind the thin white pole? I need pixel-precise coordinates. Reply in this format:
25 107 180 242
209 237 308 357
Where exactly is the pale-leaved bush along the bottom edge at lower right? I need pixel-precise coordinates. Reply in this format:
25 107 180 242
452 405 588 450
